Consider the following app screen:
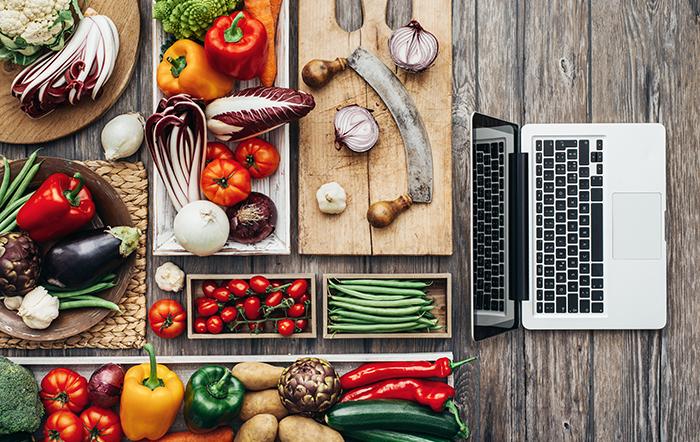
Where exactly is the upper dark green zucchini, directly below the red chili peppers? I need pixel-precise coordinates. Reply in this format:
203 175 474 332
326 400 468 440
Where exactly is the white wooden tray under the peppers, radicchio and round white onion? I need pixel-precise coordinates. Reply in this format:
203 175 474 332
151 0 291 256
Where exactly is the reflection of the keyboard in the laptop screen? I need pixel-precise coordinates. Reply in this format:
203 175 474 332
472 142 506 312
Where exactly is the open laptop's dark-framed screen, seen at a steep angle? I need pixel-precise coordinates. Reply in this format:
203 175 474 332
471 113 520 340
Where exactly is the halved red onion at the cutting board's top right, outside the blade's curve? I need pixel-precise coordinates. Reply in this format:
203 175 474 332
389 20 439 73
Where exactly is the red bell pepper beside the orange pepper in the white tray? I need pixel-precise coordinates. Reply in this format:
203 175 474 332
204 11 267 80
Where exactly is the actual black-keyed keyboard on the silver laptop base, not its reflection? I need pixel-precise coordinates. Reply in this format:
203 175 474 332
534 139 605 314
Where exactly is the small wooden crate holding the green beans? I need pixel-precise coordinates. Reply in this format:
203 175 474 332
323 273 452 339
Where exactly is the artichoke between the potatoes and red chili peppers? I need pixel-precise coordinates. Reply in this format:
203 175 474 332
277 358 341 416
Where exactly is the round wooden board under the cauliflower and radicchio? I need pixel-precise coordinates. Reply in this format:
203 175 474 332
0 0 141 144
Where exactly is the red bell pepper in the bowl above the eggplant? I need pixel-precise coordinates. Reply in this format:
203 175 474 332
17 173 95 242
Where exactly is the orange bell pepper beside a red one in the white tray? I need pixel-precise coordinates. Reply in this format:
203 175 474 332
156 40 235 101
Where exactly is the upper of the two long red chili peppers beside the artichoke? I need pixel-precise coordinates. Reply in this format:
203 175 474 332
340 357 476 390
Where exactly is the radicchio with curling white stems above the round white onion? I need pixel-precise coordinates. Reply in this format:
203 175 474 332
146 94 207 210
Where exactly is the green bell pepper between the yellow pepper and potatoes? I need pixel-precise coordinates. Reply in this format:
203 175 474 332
184 365 245 433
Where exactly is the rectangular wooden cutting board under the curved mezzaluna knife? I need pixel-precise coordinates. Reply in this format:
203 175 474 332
299 0 452 255
